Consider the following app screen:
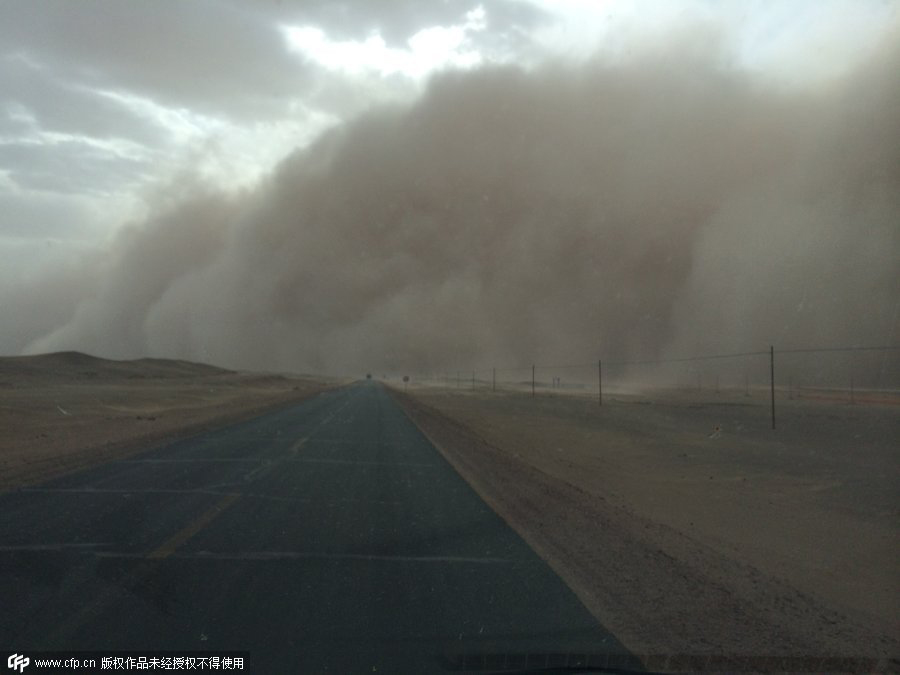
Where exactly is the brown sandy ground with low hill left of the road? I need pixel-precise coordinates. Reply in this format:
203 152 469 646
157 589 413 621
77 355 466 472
0 352 338 490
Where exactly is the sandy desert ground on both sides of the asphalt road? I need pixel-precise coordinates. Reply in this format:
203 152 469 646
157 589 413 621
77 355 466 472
0 352 900 670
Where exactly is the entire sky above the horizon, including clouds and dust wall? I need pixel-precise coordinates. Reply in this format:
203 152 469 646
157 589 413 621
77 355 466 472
0 0 900 380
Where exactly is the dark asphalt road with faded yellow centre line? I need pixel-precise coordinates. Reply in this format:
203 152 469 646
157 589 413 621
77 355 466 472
0 382 625 673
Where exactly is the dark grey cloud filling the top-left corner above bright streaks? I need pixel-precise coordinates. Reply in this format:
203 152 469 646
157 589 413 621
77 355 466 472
0 0 307 119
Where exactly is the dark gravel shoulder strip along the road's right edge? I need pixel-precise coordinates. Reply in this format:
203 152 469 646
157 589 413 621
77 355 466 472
392 390 897 658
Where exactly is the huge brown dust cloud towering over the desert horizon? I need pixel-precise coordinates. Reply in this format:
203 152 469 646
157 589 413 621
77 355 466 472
10 21 900 380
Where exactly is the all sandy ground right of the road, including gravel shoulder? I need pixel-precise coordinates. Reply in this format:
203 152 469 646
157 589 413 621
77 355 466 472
395 386 900 671
